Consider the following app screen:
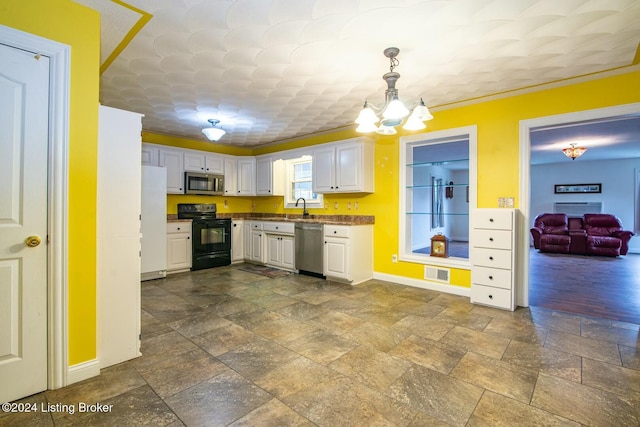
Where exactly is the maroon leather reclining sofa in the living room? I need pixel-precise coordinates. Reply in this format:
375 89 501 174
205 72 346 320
531 213 633 256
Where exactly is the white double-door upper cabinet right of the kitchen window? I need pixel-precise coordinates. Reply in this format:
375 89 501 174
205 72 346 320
312 138 374 193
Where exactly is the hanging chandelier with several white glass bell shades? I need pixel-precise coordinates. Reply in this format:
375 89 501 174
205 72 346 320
356 47 433 135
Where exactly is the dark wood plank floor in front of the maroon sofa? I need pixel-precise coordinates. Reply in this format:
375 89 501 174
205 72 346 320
529 249 640 324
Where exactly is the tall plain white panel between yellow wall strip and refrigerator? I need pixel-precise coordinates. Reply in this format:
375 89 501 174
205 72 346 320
97 106 142 369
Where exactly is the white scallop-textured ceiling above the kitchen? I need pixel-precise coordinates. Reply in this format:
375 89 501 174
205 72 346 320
76 0 640 146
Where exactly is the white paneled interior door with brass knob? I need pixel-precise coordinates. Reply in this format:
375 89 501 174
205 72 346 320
0 45 49 402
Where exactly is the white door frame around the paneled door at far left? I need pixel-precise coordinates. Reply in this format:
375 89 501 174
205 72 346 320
0 25 71 389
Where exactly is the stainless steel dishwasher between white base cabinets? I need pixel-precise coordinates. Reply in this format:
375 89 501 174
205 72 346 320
295 222 324 276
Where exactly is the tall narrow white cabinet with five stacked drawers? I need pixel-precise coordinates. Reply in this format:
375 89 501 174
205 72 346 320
471 209 517 311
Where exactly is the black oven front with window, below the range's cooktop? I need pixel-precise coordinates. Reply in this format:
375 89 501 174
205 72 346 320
191 219 231 270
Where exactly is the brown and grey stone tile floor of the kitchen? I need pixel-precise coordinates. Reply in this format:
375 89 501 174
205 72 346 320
0 266 640 427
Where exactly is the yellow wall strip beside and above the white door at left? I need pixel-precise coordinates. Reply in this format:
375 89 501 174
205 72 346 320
0 0 100 365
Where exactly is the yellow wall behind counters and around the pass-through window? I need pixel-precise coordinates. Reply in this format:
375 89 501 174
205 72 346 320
151 67 640 287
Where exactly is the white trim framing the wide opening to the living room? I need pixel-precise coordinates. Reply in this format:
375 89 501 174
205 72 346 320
516 102 640 307
